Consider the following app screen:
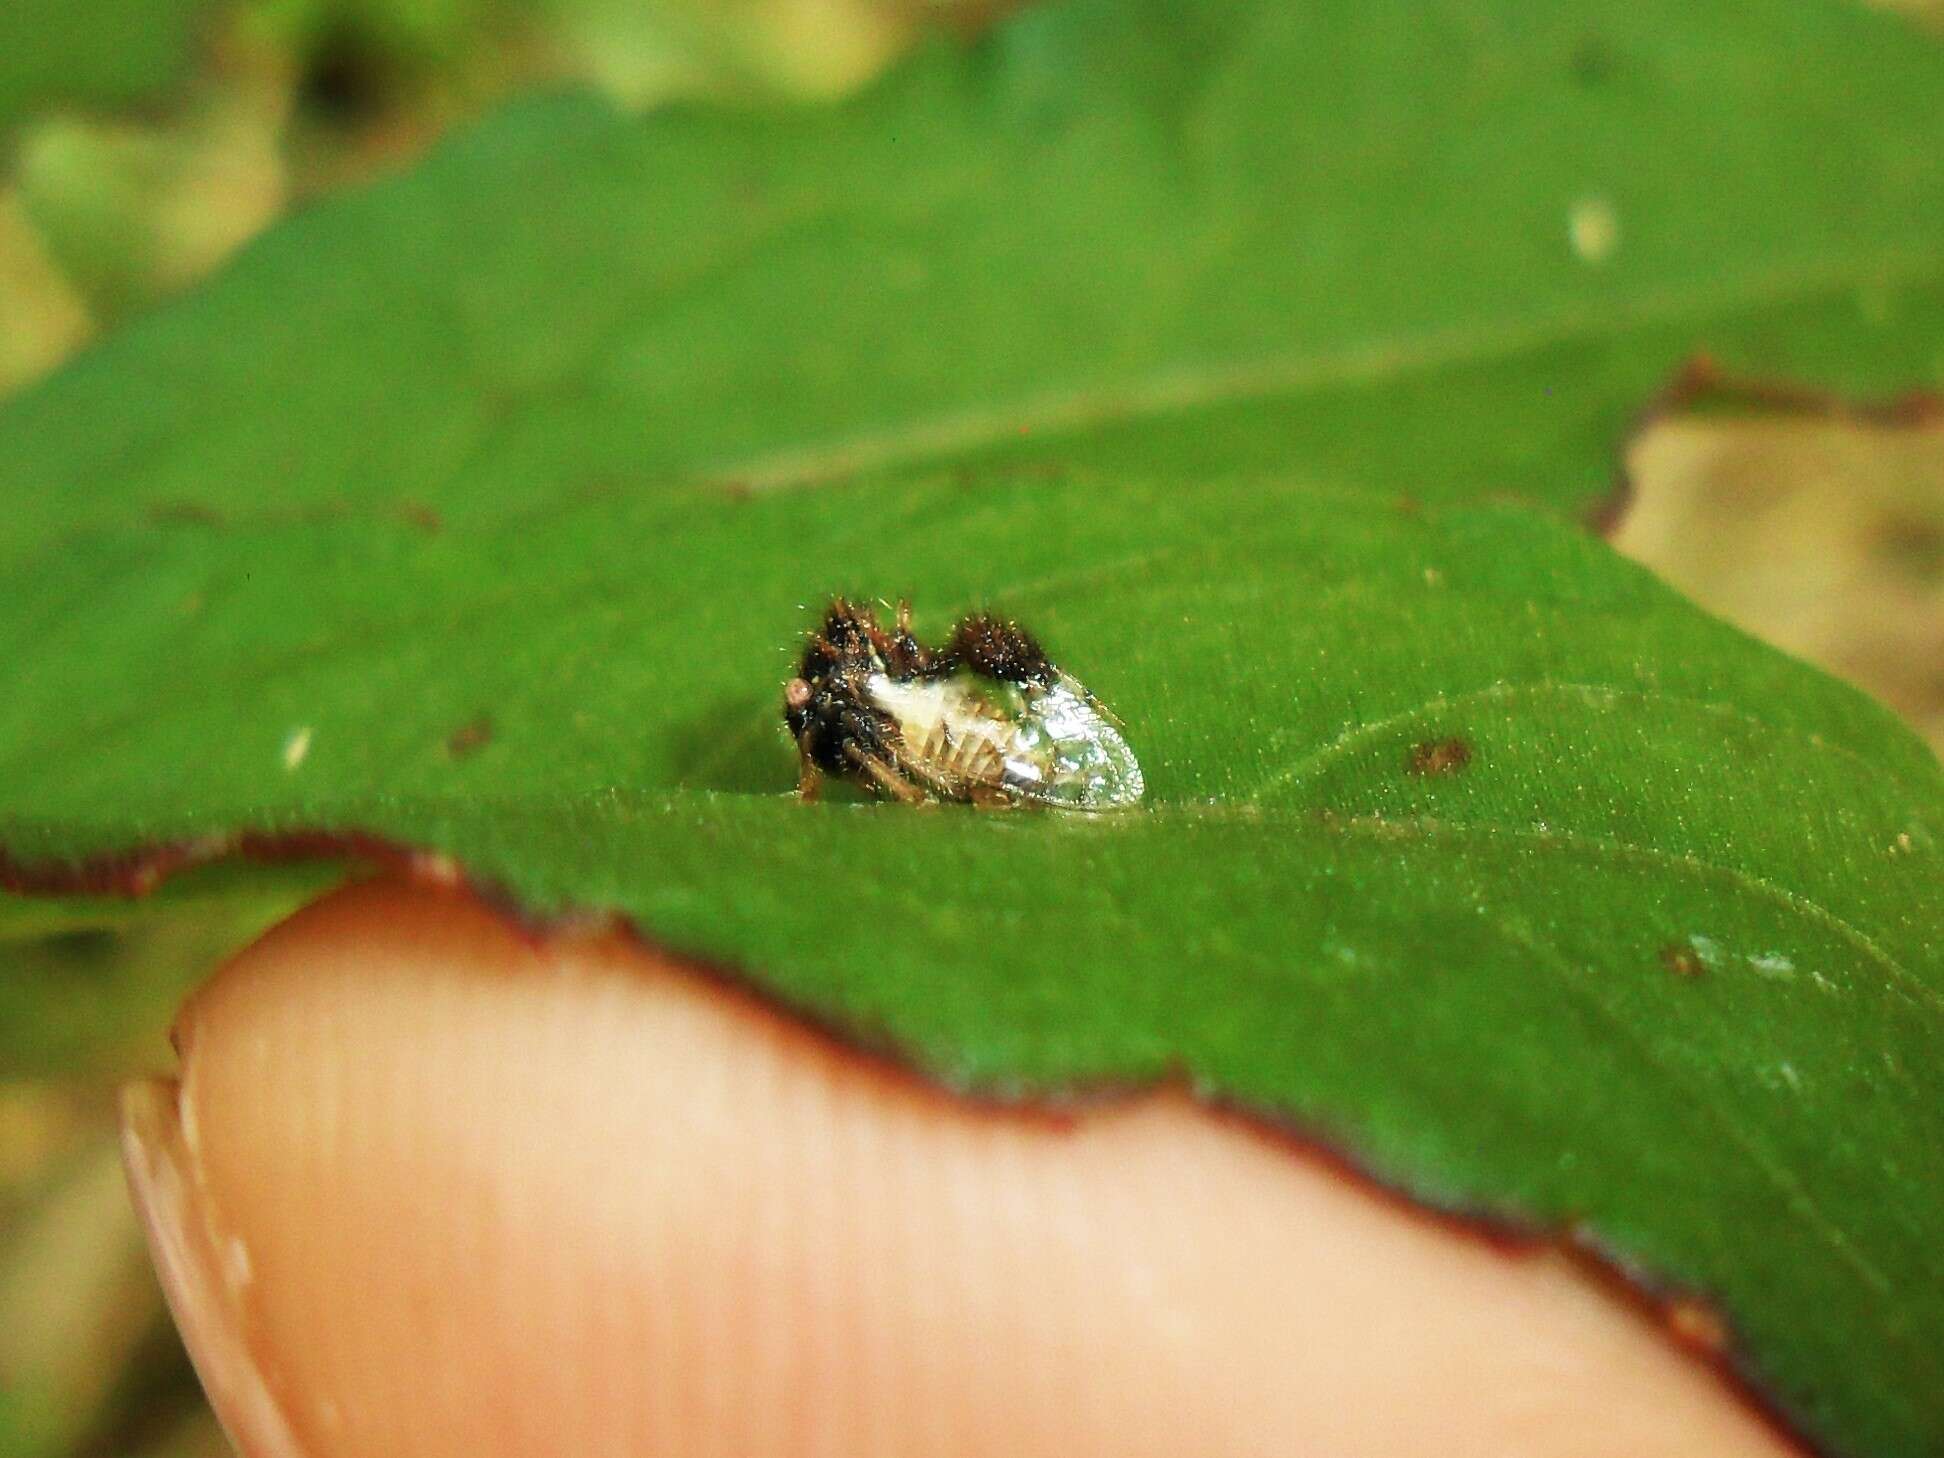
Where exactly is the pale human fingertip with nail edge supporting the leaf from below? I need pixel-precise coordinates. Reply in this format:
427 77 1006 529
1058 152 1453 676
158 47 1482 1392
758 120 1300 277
124 885 1787 1458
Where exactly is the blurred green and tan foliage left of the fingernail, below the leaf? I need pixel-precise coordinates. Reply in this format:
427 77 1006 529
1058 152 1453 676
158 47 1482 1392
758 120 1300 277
0 867 324 1458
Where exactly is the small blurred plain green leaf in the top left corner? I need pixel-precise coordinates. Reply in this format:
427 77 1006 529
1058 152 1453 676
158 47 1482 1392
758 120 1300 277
0 0 204 138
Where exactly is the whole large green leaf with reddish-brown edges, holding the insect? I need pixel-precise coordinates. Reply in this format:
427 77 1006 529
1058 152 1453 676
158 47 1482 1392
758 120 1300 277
0 0 1944 1454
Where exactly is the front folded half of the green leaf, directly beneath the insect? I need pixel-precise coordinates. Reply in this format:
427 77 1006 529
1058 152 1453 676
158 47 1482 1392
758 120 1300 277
0 472 1944 1452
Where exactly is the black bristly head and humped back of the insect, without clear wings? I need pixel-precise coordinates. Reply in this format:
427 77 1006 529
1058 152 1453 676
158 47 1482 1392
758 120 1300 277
783 597 1059 799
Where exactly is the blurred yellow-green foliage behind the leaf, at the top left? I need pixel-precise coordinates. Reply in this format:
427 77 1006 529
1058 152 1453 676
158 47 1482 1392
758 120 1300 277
0 0 952 393
